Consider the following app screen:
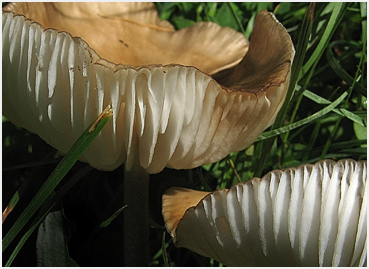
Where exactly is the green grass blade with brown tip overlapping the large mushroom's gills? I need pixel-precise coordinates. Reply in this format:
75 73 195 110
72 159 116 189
2 102 112 252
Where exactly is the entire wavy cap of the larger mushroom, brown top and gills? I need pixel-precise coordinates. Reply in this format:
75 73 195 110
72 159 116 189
3 3 294 173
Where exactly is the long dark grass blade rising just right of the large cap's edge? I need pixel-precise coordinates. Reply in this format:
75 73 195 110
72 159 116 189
254 3 315 177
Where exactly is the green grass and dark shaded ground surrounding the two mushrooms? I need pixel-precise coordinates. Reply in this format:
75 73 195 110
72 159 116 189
3 2 367 266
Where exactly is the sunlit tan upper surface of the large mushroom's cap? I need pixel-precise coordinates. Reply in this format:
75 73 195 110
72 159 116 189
4 2 248 74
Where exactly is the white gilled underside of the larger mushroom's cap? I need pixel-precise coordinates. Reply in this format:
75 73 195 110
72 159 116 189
2 13 288 173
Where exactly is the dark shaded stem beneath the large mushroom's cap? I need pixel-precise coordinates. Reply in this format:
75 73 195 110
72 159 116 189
124 161 149 266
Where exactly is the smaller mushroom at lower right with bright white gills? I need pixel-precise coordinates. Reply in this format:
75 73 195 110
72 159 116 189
162 159 367 266
